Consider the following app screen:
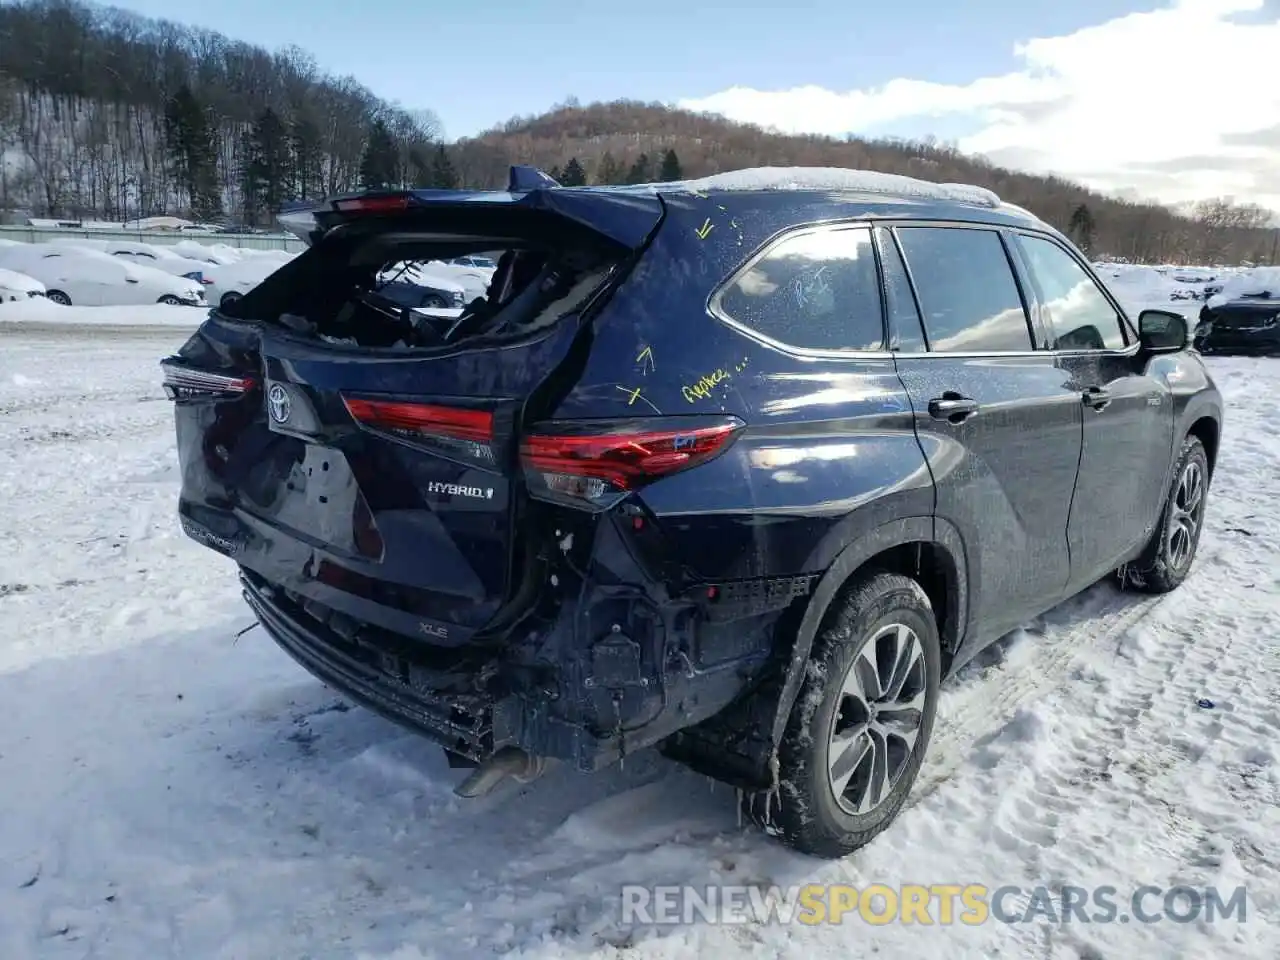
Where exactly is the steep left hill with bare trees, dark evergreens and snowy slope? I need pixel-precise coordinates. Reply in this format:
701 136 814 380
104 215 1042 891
0 0 447 224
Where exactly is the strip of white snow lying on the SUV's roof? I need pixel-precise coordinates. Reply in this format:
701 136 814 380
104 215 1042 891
624 166 1001 209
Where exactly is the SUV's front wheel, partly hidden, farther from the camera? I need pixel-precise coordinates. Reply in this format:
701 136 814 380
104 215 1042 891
1120 436 1210 594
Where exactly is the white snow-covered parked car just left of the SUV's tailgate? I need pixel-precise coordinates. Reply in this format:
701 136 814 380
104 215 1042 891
0 243 205 306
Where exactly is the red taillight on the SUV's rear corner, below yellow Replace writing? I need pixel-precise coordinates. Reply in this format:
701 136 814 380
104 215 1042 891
520 417 742 508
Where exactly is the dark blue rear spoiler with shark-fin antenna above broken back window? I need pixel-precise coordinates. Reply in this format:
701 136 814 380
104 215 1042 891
279 166 663 250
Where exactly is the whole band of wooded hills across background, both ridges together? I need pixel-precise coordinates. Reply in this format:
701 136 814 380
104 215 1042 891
0 0 1280 262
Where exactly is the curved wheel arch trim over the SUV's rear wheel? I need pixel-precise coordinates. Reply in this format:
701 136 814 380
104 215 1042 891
769 517 969 751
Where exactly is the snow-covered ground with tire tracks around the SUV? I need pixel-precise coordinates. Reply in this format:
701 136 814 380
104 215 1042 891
0 326 1280 960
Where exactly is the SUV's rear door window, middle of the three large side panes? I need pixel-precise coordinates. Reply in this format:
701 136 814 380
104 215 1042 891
897 227 1032 353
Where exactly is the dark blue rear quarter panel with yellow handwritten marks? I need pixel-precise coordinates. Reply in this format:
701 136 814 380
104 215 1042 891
553 196 933 580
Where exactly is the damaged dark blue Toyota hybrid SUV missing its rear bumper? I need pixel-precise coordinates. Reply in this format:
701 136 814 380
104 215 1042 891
164 168 1222 856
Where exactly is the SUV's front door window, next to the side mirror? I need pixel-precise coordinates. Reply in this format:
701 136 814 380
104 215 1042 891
1019 237 1124 349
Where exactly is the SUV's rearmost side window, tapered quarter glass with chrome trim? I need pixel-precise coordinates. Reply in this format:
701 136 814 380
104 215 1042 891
719 227 884 351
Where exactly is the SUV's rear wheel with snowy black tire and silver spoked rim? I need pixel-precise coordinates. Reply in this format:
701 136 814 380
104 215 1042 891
742 571 942 859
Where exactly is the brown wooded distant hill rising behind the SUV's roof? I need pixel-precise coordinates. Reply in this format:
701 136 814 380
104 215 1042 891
456 101 1276 262
